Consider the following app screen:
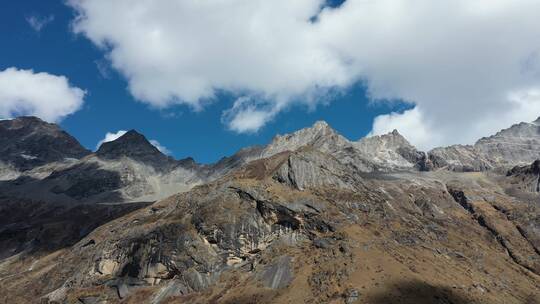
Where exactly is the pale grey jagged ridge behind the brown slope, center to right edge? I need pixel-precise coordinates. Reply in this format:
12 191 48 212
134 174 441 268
213 119 540 176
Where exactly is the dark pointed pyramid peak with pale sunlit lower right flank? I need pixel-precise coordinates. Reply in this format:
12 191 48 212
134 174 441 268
0 130 202 203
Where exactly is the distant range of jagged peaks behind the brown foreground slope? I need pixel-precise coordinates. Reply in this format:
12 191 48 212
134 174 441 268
0 117 540 202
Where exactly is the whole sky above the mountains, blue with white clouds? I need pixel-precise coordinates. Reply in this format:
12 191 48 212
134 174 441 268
0 0 540 163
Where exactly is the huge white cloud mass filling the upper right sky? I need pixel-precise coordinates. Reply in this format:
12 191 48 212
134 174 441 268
69 0 540 148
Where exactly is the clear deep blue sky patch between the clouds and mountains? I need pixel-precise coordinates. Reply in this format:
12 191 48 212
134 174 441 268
0 0 410 163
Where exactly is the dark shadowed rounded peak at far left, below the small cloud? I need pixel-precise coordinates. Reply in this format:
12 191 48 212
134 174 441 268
0 117 90 171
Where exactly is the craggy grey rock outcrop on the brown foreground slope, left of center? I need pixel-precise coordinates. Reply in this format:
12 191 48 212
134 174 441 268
27 183 329 303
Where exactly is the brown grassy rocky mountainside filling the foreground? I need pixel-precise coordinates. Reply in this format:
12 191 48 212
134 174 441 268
0 147 540 303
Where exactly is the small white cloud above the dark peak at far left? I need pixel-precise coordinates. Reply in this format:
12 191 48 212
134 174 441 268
0 68 85 122
